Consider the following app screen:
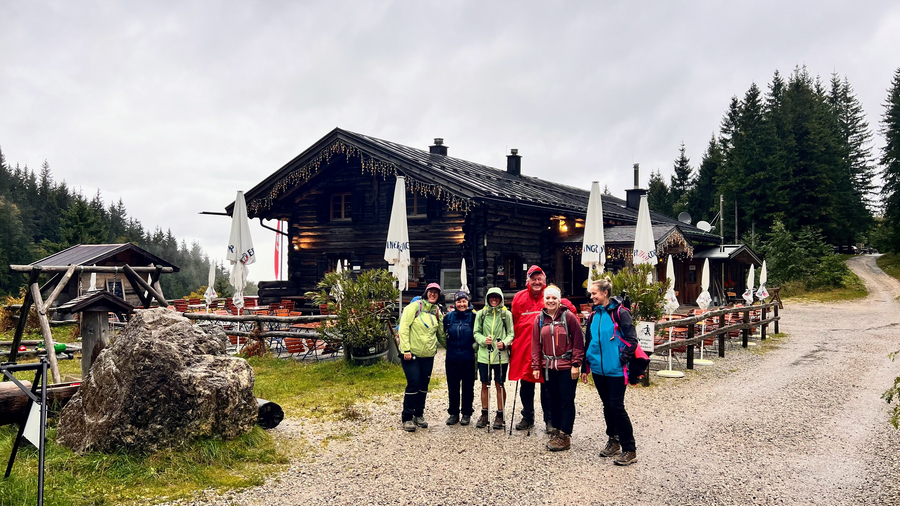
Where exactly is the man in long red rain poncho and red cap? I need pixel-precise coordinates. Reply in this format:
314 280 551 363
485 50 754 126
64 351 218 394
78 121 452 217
509 265 553 434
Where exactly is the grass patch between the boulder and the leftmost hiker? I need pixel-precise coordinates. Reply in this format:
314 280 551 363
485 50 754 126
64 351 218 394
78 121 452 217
248 357 428 420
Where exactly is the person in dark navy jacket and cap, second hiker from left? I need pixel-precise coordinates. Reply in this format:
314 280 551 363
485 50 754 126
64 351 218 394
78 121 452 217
444 291 475 425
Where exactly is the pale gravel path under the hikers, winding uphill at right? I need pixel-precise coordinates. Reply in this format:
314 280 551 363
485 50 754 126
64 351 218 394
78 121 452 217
183 256 900 505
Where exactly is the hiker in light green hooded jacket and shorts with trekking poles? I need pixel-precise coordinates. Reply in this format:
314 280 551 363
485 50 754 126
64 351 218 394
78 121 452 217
475 287 515 430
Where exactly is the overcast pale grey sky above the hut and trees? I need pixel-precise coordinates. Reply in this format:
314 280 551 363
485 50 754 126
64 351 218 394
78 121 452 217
0 0 900 280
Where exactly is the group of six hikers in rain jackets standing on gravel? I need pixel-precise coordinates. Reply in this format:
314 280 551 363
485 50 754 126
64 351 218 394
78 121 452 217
399 265 637 466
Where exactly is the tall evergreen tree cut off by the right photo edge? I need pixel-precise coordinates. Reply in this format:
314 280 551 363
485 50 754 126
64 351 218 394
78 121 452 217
880 68 900 252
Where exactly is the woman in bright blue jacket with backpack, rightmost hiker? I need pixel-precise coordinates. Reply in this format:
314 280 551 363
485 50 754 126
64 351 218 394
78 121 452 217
581 278 638 466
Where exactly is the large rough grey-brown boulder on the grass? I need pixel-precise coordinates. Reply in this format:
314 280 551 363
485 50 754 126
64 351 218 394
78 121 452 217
57 309 257 452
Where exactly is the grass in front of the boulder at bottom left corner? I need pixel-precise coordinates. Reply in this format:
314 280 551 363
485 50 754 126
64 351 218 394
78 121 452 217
0 425 287 506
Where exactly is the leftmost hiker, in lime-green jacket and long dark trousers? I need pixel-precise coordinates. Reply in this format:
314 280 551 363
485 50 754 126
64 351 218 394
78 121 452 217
400 283 444 432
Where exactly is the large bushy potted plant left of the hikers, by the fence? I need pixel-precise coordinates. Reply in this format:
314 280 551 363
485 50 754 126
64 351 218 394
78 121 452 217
306 269 399 365
